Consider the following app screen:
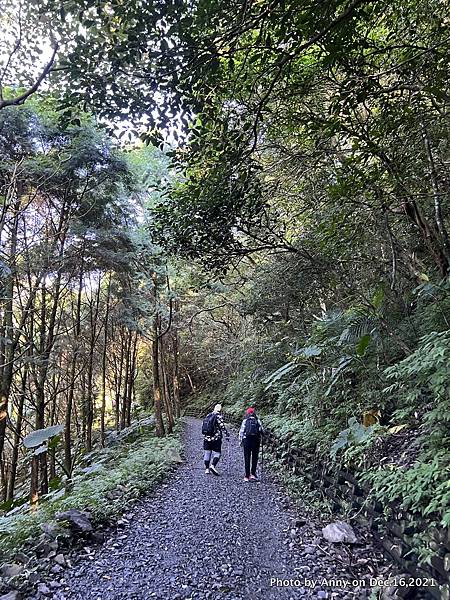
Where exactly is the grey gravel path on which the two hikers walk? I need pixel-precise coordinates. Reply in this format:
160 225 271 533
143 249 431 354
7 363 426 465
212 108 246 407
52 419 384 600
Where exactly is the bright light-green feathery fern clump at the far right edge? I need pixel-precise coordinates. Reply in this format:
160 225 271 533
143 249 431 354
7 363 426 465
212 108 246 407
352 328 450 526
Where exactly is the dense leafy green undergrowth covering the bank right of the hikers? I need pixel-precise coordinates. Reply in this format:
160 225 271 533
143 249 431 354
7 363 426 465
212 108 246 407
207 282 450 558
